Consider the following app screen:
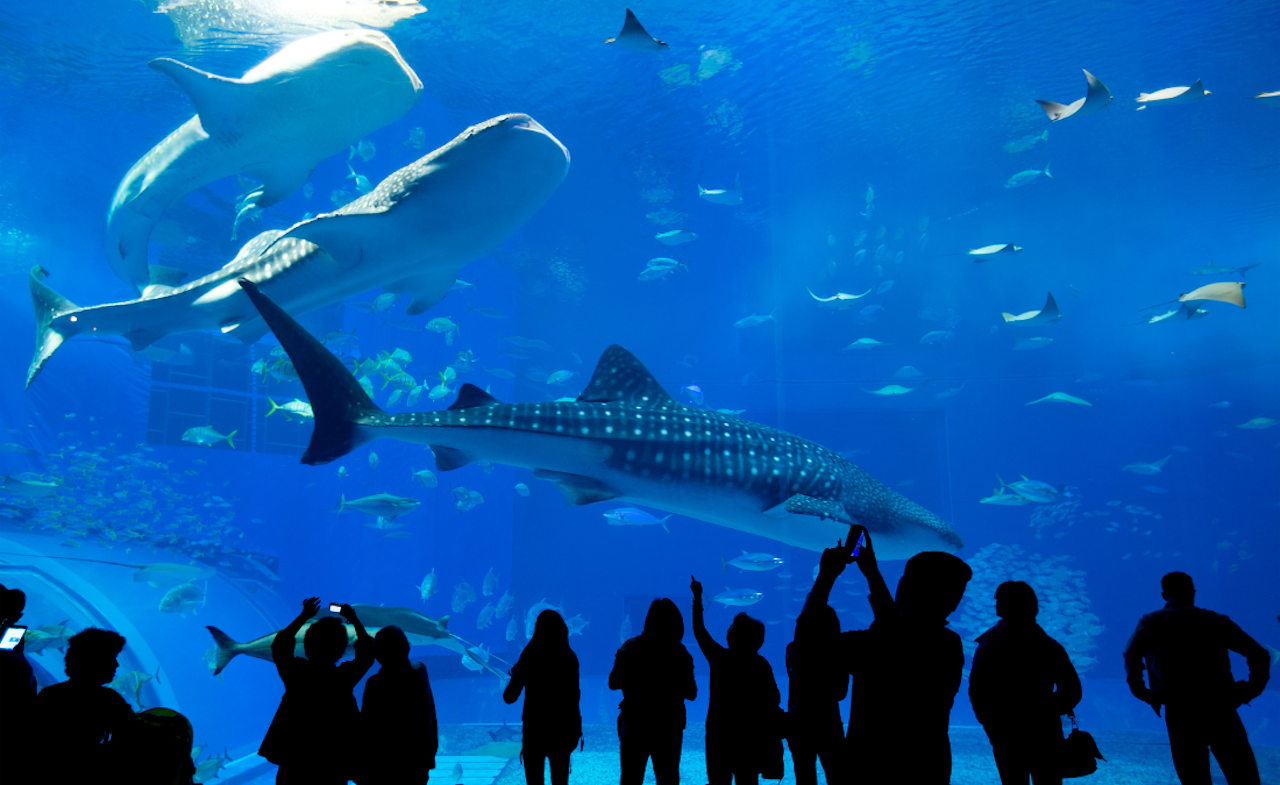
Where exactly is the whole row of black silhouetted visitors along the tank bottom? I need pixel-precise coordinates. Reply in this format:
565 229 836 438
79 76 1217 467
0 526 1270 785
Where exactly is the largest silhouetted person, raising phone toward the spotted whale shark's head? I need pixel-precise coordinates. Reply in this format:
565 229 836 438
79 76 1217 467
805 526 973 785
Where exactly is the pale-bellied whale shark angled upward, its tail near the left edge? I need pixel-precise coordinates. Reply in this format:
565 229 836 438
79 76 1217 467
27 114 568 387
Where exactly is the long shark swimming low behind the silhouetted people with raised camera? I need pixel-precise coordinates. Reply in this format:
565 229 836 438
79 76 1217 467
205 604 511 681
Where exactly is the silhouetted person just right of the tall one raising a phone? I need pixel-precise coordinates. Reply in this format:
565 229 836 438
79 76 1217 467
969 580 1082 785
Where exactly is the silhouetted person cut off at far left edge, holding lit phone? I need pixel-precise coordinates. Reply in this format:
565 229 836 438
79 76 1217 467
0 584 36 782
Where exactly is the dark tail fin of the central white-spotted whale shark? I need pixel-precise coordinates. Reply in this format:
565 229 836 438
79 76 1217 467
239 278 387 466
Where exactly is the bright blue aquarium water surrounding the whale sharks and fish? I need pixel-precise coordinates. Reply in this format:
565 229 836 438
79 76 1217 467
0 0 1280 776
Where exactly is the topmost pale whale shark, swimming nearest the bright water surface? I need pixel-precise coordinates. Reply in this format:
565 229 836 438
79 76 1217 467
104 29 422 293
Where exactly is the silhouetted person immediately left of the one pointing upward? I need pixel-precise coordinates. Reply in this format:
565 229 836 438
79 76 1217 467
609 597 698 785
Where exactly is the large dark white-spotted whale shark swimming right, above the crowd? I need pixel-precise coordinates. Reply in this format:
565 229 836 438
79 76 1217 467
241 275 963 558
